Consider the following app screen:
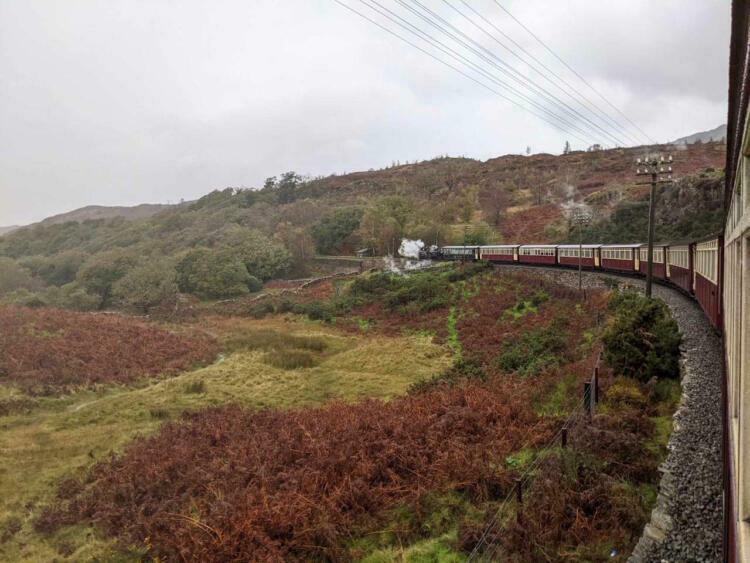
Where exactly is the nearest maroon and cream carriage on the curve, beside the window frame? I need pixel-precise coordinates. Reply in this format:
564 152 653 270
693 236 724 329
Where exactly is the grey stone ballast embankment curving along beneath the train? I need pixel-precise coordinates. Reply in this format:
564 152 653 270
501 265 722 563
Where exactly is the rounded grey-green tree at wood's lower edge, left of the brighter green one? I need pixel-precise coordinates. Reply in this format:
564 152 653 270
112 260 177 313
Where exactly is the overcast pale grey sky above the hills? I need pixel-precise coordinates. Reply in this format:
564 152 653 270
0 0 730 225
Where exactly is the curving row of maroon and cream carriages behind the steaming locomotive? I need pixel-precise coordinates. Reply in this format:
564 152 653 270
438 235 724 330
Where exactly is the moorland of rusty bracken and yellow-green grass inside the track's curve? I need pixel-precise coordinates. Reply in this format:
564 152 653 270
0 264 679 561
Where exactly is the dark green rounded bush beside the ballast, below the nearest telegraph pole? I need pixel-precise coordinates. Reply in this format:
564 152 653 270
602 291 682 382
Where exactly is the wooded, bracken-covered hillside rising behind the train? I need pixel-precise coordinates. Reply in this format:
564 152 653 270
0 143 725 311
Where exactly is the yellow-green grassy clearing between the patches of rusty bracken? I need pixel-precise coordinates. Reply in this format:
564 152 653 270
0 317 451 561
